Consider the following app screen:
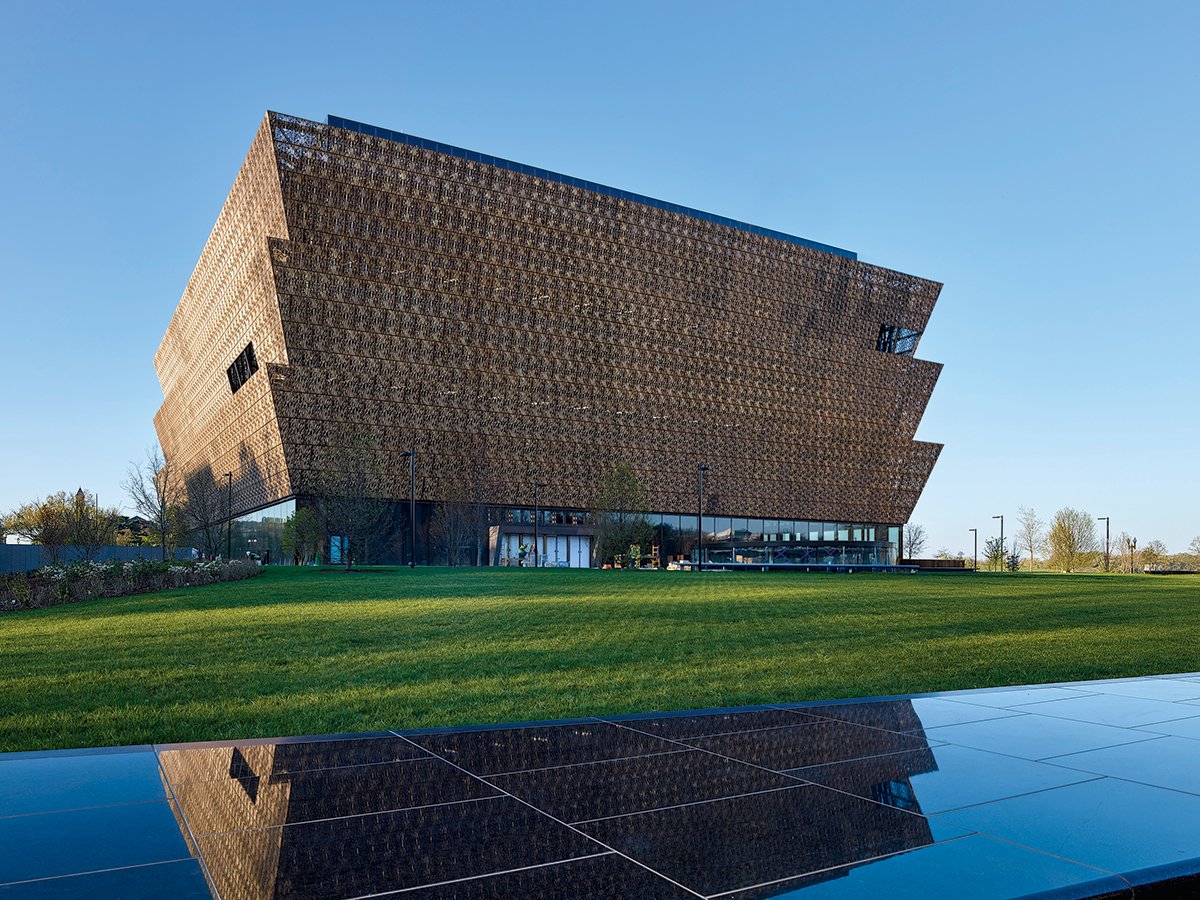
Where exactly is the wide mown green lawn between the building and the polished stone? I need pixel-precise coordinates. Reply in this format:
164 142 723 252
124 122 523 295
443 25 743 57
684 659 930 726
0 569 1200 751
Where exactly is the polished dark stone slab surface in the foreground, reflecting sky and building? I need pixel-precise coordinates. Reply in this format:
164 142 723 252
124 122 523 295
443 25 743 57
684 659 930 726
0 673 1200 900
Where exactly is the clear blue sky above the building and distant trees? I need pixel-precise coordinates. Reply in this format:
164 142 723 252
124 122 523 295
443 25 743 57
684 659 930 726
0 0 1200 553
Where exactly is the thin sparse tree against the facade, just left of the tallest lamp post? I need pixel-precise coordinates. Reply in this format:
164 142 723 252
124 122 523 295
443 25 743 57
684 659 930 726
314 433 384 571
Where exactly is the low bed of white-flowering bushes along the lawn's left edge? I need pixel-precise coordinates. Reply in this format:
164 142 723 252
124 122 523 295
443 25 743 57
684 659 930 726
0 559 262 612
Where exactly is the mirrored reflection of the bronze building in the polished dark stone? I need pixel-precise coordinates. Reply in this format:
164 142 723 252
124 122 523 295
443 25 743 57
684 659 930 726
160 701 936 900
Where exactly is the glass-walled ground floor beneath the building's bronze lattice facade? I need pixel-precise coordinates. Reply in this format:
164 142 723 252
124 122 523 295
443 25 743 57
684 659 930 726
222 498 901 569
